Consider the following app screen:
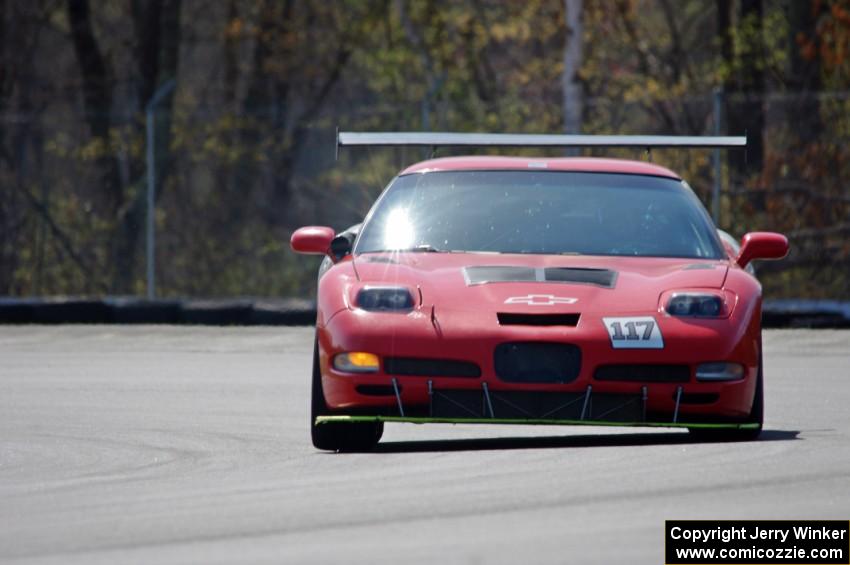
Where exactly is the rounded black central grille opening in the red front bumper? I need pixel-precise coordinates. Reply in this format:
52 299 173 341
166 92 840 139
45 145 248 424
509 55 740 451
493 341 581 384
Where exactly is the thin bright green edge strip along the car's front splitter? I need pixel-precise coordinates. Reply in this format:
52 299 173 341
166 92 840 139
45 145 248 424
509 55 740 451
316 415 759 430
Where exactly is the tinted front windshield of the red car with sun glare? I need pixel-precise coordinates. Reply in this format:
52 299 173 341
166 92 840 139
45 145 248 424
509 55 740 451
355 171 723 259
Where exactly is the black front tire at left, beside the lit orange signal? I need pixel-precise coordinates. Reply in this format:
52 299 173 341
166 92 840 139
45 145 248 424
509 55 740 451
310 342 384 451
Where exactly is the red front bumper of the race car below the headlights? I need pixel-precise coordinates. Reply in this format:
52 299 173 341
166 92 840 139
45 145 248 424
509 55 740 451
319 310 760 423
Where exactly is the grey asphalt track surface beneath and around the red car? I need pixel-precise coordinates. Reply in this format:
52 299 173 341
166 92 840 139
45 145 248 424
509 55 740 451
0 326 850 564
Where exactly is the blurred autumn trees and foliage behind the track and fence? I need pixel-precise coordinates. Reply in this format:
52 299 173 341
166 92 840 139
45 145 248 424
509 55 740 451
0 0 850 299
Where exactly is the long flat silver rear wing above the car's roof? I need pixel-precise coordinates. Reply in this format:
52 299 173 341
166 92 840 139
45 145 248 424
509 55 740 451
336 131 747 160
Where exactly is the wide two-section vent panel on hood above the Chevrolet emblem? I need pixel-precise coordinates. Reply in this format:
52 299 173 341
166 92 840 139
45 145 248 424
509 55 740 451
463 266 617 288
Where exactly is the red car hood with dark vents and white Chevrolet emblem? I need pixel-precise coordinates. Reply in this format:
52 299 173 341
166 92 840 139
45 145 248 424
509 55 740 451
354 252 729 314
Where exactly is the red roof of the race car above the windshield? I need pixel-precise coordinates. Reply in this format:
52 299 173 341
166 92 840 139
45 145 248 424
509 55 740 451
401 156 680 180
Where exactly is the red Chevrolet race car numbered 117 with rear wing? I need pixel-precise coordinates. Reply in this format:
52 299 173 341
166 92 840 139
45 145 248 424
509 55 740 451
291 133 788 450
